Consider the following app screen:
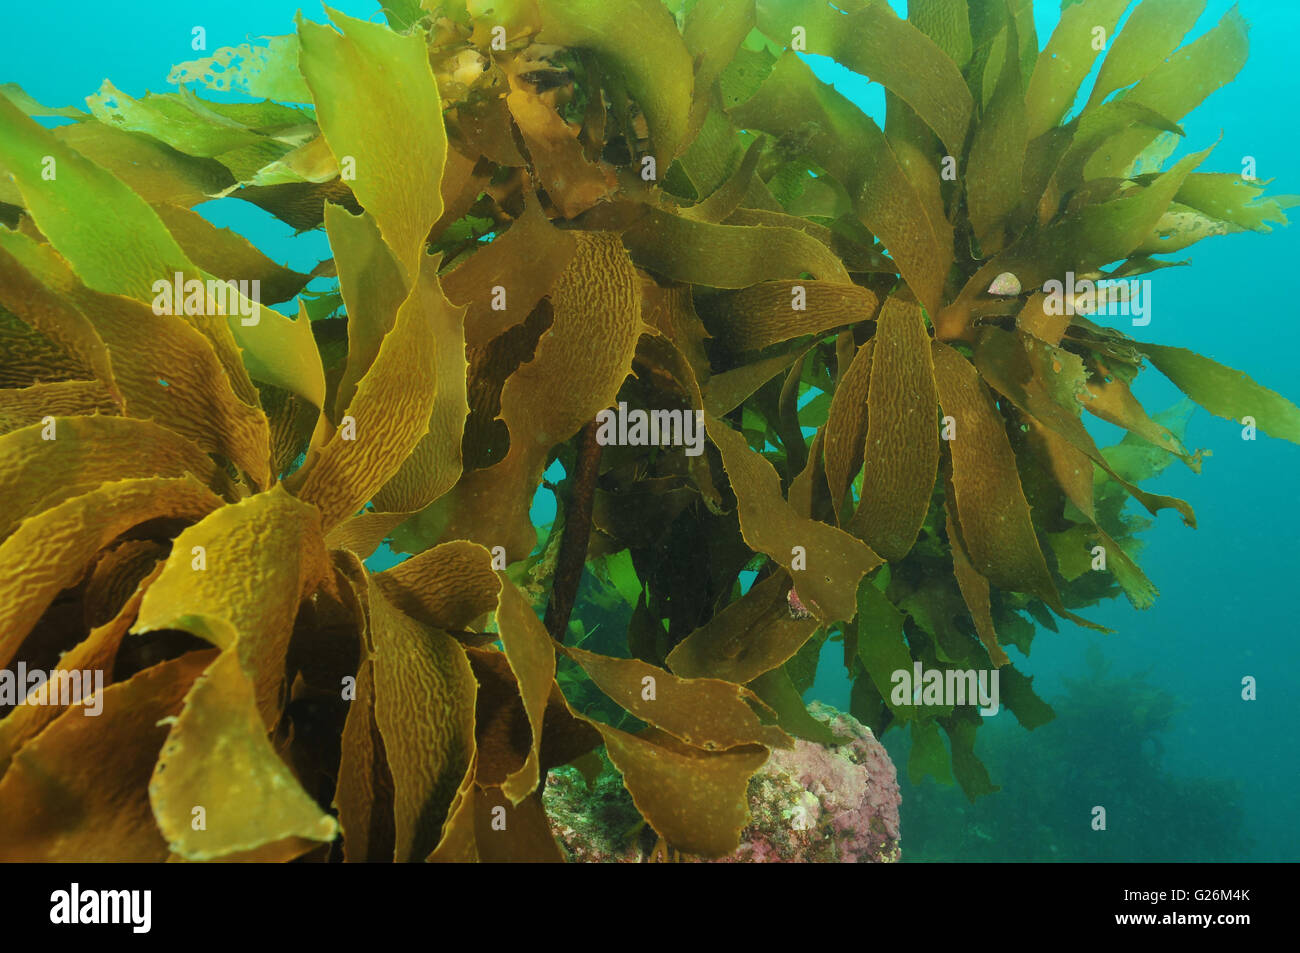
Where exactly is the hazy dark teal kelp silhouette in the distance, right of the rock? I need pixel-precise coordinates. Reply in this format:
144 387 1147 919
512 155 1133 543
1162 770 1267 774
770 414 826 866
904 646 1252 862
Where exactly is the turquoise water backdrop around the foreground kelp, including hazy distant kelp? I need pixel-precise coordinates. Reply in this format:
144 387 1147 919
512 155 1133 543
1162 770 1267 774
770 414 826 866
0 0 1300 861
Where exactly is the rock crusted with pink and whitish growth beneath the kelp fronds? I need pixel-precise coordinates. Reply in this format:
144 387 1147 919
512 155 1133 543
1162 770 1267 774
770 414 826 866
543 702 902 863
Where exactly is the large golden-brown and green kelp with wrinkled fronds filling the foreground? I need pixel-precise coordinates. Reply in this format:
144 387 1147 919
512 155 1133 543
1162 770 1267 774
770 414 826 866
0 0 1300 861
